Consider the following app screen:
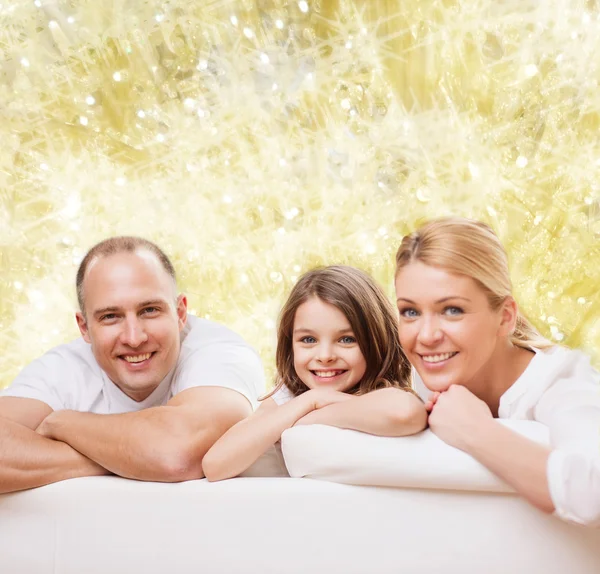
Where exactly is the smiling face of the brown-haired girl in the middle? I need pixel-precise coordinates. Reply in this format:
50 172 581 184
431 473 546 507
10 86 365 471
292 297 367 391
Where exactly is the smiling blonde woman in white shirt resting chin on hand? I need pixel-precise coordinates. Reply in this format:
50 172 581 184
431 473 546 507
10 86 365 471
396 218 600 526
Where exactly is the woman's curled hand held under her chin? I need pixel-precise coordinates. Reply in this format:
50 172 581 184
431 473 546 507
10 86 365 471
428 385 494 452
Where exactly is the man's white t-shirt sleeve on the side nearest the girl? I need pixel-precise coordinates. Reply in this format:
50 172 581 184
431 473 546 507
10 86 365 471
173 342 265 409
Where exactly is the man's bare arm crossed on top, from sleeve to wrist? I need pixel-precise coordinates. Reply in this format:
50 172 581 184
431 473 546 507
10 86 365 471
29 387 251 482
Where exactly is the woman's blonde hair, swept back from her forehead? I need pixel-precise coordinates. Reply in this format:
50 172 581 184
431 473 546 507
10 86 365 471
396 217 552 350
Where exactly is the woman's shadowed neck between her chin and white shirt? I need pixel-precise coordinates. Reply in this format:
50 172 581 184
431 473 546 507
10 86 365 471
469 341 535 417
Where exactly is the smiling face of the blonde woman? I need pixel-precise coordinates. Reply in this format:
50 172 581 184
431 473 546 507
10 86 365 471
396 262 511 392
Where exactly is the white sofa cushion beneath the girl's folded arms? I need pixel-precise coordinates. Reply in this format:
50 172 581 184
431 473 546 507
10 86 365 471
281 420 548 492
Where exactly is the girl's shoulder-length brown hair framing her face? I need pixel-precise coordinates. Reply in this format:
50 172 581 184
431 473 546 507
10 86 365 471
264 265 414 398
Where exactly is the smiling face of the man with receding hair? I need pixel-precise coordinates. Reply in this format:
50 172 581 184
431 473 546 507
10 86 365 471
77 249 187 401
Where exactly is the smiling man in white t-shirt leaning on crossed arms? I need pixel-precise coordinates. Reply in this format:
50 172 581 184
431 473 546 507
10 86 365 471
0 237 264 493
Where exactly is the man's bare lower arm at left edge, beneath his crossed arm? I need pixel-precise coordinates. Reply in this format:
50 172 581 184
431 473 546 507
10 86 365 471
0 418 109 493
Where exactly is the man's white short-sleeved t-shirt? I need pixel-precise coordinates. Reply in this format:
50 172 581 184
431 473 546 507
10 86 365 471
0 315 265 414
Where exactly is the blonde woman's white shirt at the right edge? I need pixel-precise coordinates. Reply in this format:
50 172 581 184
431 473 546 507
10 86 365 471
413 346 600 526
